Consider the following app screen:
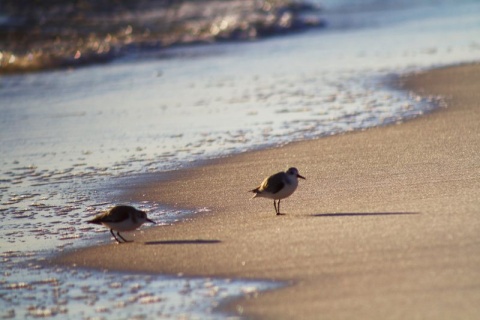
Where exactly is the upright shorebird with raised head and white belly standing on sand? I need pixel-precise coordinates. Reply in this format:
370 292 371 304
250 168 305 215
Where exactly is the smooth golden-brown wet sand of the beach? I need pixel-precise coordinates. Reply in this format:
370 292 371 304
55 64 480 319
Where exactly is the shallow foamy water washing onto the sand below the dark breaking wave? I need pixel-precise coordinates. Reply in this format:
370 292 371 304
0 0 480 319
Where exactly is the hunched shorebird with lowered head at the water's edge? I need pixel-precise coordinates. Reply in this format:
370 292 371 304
87 206 155 243
